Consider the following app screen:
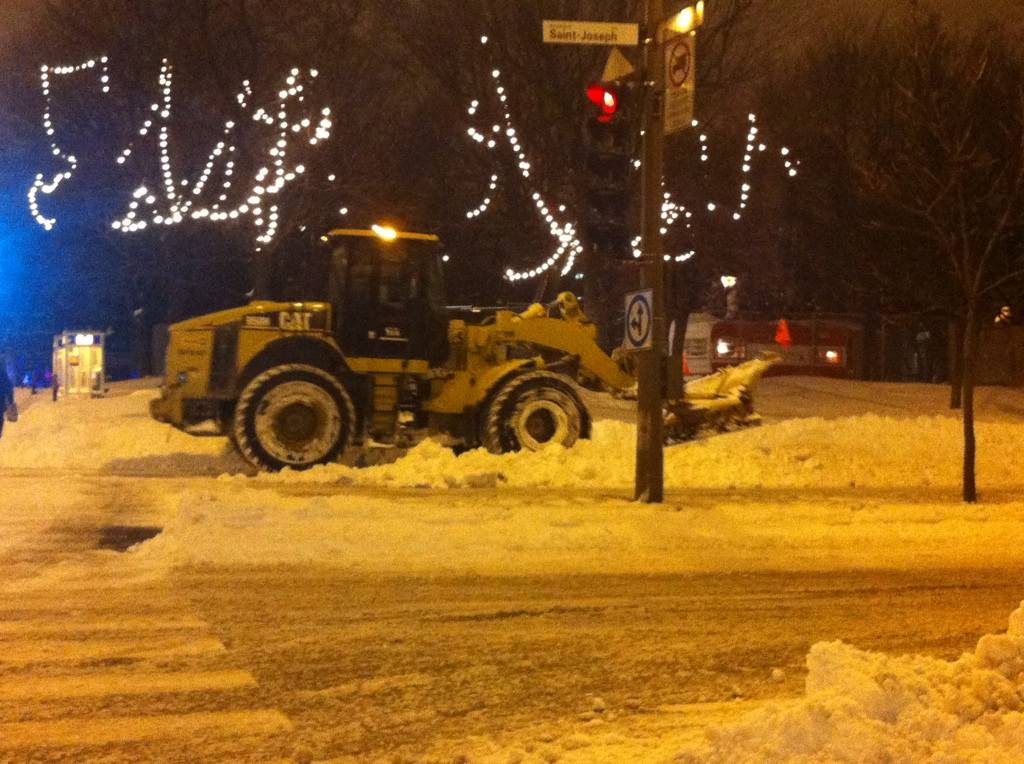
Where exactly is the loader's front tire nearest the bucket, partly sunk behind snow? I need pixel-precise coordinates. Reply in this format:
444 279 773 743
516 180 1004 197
480 371 589 454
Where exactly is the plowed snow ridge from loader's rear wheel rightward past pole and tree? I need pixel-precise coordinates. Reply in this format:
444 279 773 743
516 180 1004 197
260 414 1024 489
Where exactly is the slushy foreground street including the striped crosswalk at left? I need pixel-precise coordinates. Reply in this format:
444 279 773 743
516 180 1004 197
0 477 1020 762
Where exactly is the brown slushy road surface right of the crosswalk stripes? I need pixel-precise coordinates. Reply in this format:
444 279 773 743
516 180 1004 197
175 566 1020 762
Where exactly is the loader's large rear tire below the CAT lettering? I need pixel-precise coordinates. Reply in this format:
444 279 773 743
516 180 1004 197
233 364 355 470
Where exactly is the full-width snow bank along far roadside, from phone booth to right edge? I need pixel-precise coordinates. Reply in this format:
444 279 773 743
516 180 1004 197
0 383 1024 492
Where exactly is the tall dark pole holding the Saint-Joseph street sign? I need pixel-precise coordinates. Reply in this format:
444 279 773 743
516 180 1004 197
634 0 666 504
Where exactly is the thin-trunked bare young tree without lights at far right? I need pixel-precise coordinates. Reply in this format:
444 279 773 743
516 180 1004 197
831 16 1024 502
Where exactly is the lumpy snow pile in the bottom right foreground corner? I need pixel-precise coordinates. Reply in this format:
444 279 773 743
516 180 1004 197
676 602 1024 764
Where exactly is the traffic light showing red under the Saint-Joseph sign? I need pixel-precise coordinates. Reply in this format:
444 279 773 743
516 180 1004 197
583 82 636 260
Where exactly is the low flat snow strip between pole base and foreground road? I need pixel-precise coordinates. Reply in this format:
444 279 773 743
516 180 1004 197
128 473 1024 576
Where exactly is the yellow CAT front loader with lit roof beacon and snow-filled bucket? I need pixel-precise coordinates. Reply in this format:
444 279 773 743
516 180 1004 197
152 226 771 469
